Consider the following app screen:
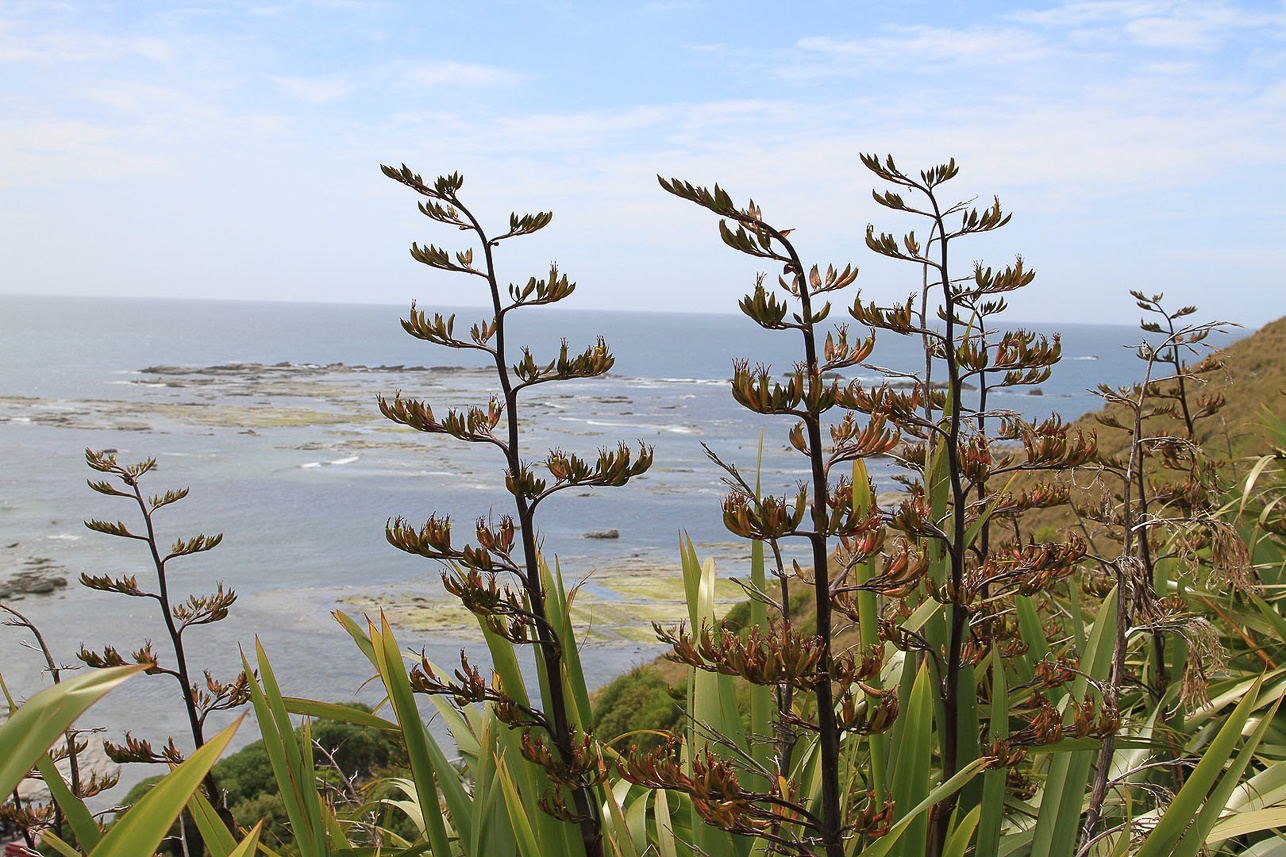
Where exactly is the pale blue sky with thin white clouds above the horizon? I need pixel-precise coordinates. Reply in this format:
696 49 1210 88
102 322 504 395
0 0 1286 327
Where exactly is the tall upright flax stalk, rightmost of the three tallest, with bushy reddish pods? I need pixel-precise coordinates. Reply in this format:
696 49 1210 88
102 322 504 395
853 156 1115 854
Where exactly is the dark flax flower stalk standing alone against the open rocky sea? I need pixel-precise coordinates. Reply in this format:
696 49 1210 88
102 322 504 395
379 166 652 857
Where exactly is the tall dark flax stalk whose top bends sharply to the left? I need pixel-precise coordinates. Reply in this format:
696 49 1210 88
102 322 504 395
640 172 899 857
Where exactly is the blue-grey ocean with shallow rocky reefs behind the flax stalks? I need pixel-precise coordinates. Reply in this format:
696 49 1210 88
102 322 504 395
0 296 1213 782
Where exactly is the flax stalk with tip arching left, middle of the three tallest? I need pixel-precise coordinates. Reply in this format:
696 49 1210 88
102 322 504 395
637 179 879 857
